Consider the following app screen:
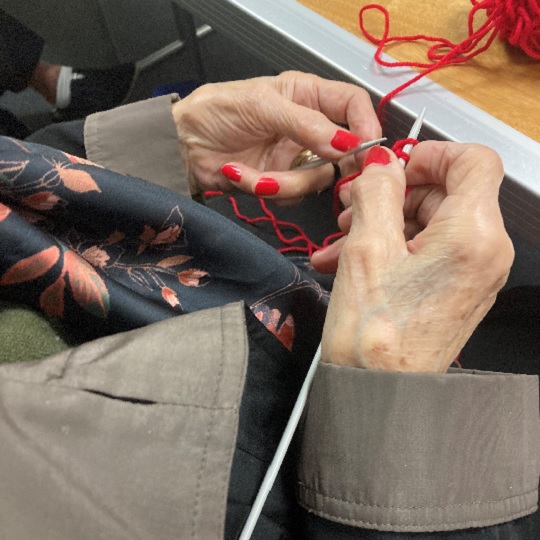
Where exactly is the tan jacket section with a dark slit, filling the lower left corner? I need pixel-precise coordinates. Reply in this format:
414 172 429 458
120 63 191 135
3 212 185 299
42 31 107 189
0 303 248 540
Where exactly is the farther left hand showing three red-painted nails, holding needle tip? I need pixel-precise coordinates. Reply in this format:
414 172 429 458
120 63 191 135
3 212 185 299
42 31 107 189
173 72 381 202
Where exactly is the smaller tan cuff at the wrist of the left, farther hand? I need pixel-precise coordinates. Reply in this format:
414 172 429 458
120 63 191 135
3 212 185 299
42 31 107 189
84 94 190 197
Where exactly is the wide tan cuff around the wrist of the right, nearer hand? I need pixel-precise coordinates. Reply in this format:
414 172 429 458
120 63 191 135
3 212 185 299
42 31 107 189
297 363 540 532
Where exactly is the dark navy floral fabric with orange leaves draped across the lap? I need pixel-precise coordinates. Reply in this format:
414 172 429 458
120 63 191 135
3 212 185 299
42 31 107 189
0 137 332 352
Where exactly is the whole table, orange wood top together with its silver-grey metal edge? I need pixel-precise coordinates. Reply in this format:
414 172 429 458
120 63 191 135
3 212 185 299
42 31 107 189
175 0 540 247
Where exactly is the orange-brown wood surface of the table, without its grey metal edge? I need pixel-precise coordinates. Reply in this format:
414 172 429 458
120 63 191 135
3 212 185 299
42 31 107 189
299 0 540 142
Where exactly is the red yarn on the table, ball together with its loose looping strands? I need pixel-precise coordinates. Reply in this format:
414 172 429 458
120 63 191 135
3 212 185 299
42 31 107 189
358 0 540 119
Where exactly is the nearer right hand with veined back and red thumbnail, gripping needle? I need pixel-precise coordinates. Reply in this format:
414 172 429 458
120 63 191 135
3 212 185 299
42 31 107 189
313 142 513 372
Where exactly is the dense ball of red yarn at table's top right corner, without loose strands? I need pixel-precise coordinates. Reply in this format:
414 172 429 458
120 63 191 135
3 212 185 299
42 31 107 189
488 0 540 60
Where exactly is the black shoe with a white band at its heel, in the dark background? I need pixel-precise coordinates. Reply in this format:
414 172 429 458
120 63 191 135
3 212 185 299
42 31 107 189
54 64 136 121
